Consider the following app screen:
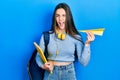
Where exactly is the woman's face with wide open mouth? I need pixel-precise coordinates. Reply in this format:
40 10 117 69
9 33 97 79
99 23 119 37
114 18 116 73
55 8 66 31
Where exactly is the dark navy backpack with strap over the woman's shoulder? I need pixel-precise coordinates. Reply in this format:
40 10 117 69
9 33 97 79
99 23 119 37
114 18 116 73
27 32 49 80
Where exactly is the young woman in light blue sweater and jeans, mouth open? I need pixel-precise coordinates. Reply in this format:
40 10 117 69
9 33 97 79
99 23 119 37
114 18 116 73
36 3 95 80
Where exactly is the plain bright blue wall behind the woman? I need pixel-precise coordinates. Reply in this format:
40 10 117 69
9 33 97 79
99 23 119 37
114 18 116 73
0 0 120 80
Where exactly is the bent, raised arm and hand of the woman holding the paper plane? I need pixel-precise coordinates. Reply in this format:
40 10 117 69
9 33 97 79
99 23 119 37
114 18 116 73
76 32 95 66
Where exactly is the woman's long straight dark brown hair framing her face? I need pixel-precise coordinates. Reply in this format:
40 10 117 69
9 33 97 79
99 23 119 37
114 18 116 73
51 3 81 42
